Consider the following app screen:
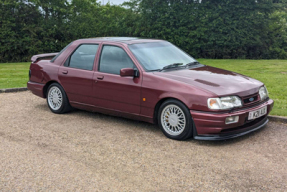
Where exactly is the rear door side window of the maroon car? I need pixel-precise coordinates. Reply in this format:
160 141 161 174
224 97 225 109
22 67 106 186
68 44 99 70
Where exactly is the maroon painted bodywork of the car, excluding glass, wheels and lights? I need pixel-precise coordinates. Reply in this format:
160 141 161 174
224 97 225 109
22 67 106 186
28 38 273 135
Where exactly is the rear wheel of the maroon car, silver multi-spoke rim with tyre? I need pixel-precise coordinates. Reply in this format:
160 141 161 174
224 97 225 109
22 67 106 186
47 83 72 114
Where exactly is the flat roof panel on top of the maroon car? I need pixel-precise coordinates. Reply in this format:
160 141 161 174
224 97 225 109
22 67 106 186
76 37 164 44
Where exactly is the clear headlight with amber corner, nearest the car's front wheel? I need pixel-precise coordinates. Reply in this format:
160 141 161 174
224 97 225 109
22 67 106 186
207 96 242 109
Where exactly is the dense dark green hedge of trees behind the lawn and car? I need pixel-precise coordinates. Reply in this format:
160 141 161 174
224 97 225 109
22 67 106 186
0 0 287 62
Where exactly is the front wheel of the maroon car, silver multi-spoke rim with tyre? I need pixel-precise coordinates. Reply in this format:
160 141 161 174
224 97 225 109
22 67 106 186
158 99 193 140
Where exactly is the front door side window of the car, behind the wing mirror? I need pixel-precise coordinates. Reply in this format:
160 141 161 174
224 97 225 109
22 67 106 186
99 45 135 75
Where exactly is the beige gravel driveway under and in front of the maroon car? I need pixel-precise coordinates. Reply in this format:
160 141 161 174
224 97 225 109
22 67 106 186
0 91 287 191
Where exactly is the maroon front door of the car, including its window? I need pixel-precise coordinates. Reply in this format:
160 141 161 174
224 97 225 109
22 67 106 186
93 45 141 114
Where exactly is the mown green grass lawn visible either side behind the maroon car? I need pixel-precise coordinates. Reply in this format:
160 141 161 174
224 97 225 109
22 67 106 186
0 59 287 116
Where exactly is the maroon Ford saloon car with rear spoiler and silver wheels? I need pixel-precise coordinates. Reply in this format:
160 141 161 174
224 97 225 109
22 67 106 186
28 37 273 140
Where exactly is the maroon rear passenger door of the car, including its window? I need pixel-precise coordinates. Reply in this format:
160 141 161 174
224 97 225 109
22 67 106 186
58 44 99 104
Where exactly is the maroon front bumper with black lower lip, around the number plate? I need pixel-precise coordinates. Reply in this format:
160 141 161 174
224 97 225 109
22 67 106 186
190 99 274 140
